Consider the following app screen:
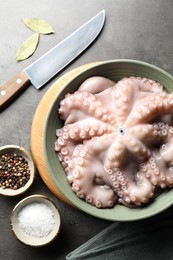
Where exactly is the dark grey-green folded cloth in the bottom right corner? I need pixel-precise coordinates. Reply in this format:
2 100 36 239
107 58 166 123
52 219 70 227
66 208 173 260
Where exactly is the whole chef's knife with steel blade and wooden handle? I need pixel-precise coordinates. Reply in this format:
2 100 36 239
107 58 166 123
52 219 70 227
0 10 105 110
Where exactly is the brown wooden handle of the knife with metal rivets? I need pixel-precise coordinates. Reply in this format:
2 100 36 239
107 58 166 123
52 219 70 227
0 71 29 111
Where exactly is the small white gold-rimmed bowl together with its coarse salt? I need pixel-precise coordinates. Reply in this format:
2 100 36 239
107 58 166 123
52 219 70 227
10 195 61 247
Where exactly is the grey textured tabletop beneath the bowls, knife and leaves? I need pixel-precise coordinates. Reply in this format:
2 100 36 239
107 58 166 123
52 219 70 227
0 0 173 260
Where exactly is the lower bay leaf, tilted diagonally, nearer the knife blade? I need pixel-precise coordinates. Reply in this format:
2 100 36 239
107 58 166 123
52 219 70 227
16 33 39 61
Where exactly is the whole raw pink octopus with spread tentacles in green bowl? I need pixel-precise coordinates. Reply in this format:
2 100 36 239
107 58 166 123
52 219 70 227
55 76 173 208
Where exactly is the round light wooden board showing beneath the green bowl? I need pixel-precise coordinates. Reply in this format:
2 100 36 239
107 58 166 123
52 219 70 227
31 63 96 206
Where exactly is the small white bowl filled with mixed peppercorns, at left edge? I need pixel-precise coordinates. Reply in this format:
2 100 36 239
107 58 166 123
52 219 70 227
0 145 36 196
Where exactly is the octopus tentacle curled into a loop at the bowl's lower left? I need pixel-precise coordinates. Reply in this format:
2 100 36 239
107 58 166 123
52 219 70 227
68 145 117 208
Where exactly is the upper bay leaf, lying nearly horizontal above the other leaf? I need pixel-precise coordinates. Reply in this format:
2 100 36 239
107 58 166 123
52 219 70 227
22 18 54 34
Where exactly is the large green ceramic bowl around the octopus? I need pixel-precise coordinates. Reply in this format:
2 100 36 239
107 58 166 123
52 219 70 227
43 60 173 221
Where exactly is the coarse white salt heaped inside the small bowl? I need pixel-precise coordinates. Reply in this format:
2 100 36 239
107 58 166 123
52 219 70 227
18 202 55 238
